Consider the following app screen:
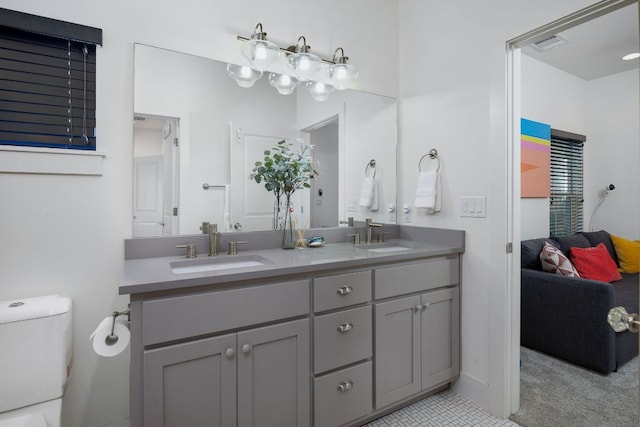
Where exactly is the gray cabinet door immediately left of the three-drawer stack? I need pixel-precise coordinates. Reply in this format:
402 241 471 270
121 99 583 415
238 319 311 427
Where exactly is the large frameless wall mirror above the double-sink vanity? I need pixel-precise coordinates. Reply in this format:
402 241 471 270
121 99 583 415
133 44 397 237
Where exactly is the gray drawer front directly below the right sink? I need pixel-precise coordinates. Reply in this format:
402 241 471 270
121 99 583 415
374 255 460 299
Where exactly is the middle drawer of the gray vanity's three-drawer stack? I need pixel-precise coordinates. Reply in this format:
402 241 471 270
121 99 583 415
314 306 373 374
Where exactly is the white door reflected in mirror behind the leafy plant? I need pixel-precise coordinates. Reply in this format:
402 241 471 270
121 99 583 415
230 123 309 231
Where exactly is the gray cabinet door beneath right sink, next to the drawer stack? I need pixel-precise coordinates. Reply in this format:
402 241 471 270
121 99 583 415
375 296 421 409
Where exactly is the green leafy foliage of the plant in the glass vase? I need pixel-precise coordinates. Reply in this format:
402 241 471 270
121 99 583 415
249 140 315 201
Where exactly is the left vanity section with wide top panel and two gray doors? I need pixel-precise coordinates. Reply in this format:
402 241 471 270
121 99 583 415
132 278 311 427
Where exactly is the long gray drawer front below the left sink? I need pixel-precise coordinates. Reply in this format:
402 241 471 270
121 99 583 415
142 280 309 345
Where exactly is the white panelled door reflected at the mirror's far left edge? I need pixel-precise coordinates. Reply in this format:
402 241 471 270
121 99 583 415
133 156 164 237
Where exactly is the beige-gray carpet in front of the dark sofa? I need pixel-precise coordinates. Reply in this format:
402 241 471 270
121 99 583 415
510 347 638 427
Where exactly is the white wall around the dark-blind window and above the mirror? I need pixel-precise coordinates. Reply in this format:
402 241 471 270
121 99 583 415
0 0 398 427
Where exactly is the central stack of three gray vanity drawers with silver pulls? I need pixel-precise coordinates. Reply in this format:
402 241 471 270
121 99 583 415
313 270 373 427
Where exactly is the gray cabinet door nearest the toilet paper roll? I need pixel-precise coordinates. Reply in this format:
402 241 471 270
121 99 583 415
143 334 236 427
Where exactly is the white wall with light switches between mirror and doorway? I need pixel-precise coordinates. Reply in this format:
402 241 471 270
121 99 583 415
398 0 592 416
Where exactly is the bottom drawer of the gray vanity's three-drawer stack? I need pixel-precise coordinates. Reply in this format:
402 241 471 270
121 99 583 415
314 362 373 427
